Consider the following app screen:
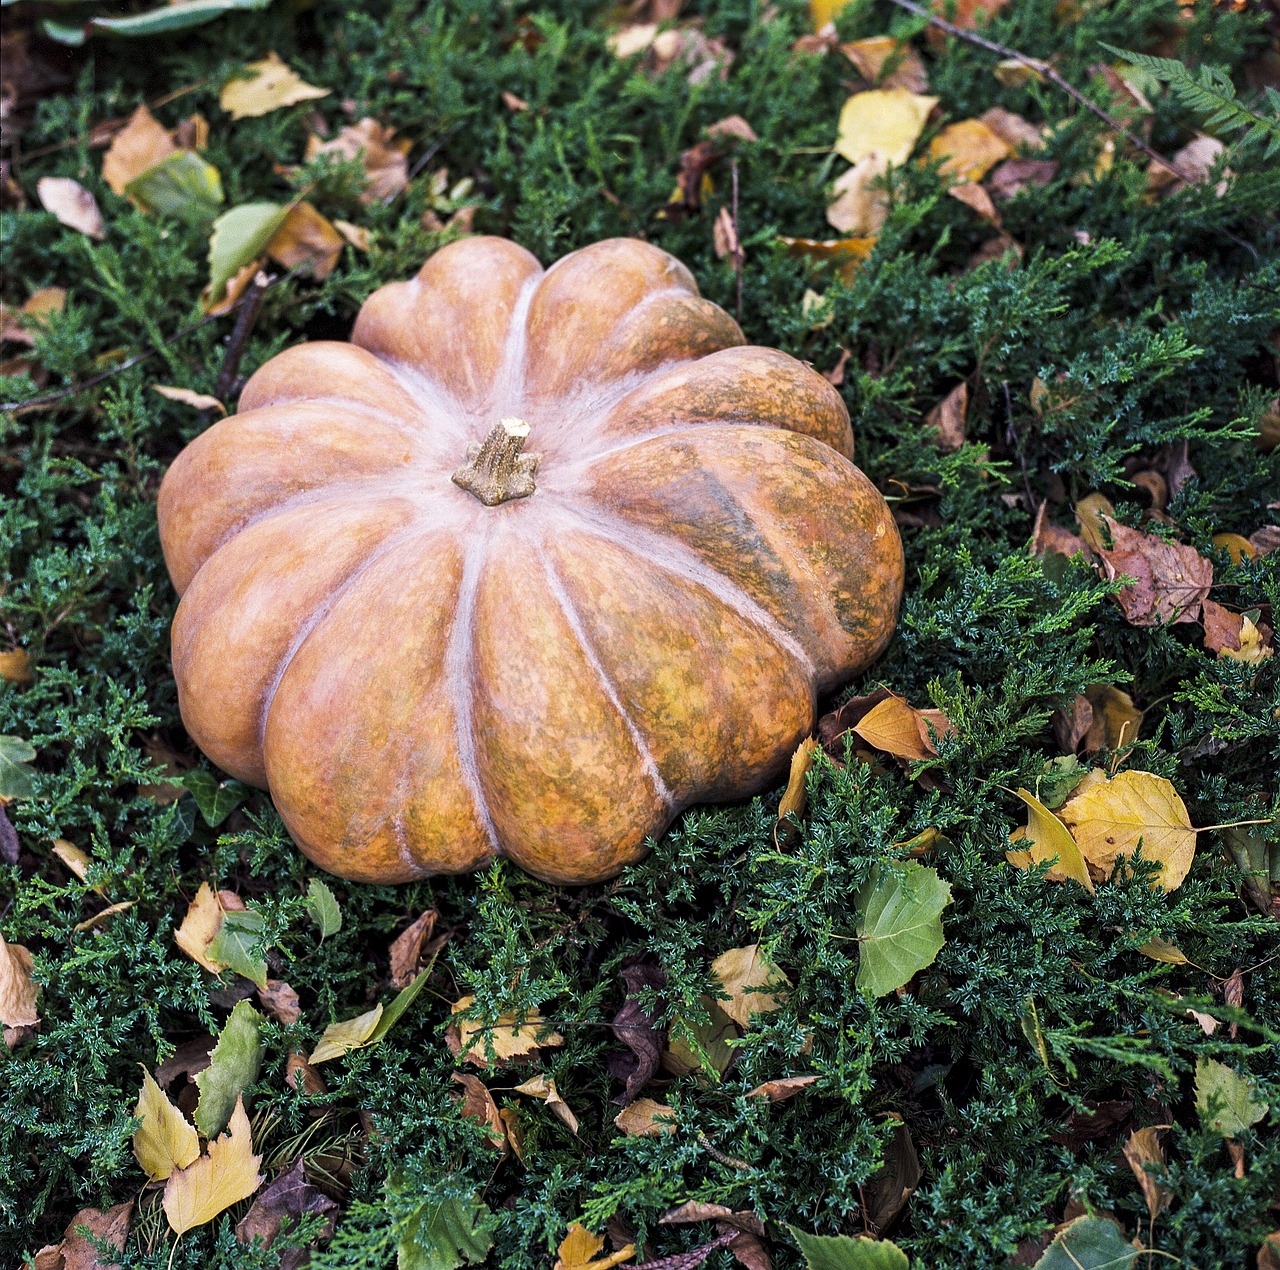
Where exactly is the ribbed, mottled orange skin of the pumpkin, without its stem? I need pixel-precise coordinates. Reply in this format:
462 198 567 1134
159 238 902 883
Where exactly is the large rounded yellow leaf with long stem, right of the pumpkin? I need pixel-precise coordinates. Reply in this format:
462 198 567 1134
1062 772 1196 891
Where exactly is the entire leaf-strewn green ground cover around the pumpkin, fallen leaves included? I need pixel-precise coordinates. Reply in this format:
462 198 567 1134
0 0 1280 1270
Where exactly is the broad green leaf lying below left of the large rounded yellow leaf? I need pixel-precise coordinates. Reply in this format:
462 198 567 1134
856 862 951 996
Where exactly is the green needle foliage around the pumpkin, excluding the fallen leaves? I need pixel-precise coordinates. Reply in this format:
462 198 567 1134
0 0 1280 1270
